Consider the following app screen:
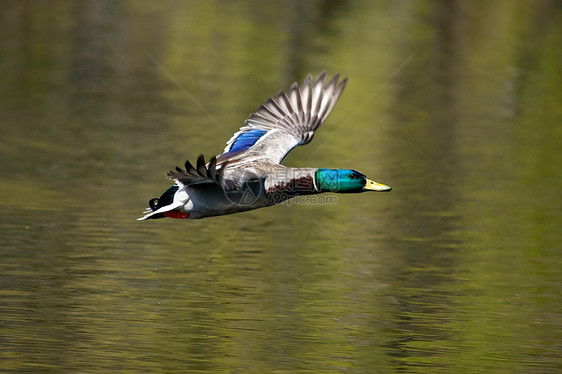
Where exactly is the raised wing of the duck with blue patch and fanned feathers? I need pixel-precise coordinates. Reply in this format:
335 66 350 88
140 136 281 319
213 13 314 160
217 71 347 164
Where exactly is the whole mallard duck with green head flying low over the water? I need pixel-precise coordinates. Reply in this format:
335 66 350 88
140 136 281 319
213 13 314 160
139 72 391 220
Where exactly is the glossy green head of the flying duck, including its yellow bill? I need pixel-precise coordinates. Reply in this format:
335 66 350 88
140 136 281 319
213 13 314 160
315 169 392 193
